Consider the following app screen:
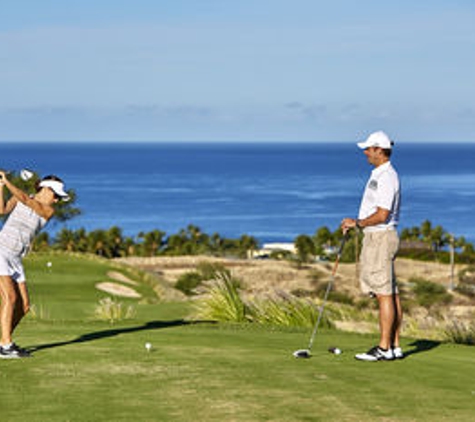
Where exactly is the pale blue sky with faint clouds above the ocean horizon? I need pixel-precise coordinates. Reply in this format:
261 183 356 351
0 0 475 142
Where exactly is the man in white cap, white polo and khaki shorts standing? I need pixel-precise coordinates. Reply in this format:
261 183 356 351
341 131 403 361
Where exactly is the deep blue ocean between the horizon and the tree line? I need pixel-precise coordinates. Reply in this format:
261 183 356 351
0 142 475 243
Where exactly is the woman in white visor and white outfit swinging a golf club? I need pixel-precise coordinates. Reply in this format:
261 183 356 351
0 171 68 358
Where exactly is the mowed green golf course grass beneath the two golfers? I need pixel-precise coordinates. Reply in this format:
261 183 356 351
0 255 475 421
